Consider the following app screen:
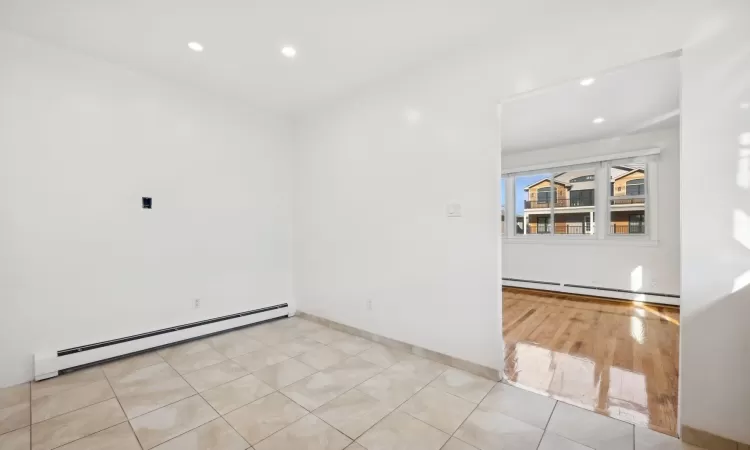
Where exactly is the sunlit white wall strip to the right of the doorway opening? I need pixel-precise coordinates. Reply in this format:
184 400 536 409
680 20 750 444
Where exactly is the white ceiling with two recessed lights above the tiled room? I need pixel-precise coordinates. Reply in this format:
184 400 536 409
0 0 531 112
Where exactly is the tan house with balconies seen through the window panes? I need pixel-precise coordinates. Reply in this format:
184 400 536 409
522 166 646 234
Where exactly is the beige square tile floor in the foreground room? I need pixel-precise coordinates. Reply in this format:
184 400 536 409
0 318 696 450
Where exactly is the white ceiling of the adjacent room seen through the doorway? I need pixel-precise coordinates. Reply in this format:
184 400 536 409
501 57 680 152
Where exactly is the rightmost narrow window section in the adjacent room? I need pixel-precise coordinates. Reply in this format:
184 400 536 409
608 162 647 236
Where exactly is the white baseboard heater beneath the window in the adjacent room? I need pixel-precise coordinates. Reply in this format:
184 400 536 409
503 277 680 306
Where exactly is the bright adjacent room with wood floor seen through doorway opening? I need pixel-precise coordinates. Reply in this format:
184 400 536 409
500 54 680 435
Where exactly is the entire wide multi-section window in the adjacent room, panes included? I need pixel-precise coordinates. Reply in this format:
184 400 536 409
501 152 658 239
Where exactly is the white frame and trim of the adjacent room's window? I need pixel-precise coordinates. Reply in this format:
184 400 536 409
501 148 660 245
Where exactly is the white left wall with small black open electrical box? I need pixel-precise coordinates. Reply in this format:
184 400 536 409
0 33 292 386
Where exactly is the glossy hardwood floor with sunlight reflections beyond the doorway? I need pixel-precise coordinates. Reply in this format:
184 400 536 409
503 288 680 435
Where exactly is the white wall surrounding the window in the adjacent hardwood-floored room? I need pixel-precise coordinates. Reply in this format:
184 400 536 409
502 128 680 302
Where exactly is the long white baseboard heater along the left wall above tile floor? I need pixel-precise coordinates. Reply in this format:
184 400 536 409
34 303 291 381
